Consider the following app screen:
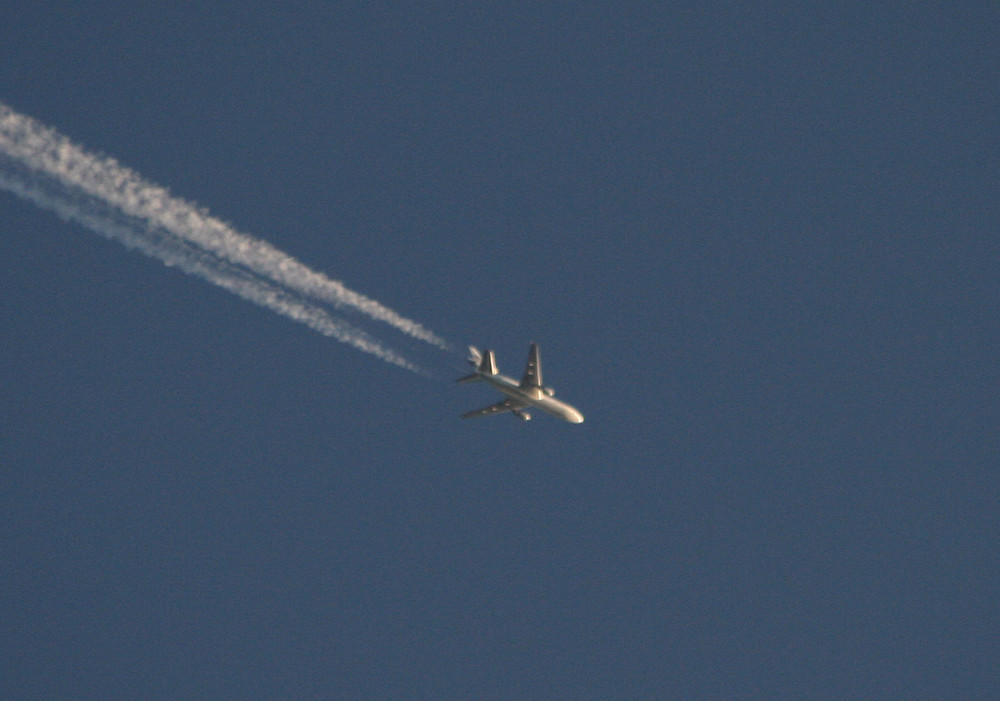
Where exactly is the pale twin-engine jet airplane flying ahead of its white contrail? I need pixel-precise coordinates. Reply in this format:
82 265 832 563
456 343 583 424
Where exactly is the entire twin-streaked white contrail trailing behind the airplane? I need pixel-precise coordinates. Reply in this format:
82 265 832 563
0 102 450 372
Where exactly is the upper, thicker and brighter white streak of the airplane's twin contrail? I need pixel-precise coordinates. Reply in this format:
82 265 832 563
0 102 450 349
